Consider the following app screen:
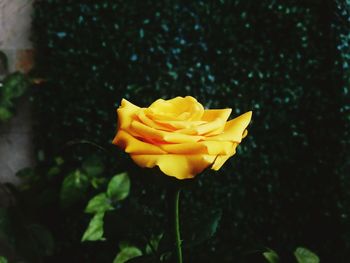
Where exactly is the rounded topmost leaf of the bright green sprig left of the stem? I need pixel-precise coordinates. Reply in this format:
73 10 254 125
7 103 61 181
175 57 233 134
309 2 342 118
107 173 130 201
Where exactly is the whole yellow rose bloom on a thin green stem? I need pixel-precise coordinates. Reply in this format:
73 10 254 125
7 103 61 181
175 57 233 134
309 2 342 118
113 96 252 179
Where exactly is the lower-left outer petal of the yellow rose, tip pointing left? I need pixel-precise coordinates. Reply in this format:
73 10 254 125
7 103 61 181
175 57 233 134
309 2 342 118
113 130 166 154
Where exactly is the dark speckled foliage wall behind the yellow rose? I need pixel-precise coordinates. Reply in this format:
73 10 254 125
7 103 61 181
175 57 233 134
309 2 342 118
34 0 350 262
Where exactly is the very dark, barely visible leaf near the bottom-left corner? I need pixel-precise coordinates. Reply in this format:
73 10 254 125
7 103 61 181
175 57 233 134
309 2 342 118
27 224 54 256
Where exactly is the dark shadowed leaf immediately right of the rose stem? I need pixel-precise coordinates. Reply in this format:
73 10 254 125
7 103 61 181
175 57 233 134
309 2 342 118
184 210 222 247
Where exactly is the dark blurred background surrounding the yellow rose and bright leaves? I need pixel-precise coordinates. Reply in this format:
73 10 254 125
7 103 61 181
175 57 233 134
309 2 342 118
0 0 350 262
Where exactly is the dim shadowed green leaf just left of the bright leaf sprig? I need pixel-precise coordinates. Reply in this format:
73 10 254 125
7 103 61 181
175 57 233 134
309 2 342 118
60 170 89 207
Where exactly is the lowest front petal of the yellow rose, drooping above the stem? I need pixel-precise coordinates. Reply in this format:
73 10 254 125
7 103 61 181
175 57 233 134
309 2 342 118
131 154 215 179
